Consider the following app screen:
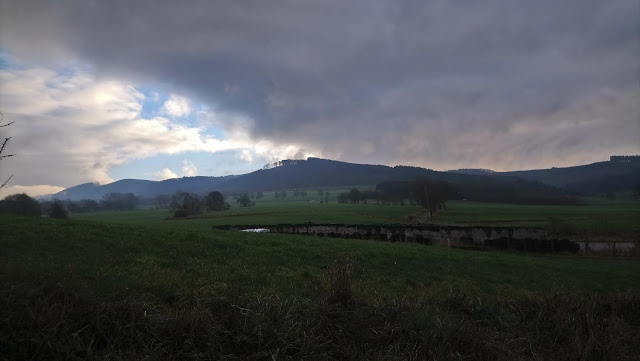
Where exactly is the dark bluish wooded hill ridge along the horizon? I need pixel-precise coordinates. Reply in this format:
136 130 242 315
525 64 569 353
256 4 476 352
52 157 640 200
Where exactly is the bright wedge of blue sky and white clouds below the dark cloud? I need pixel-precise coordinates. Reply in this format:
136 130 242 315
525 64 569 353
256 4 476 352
0 49 306 194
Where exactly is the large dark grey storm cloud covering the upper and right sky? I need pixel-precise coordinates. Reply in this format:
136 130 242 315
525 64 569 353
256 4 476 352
2 0 640 169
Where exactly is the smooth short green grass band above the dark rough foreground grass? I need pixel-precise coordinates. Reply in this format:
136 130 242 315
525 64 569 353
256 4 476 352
0 214 640 302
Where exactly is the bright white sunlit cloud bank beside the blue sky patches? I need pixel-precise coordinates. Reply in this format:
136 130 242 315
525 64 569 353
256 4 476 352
0 68 291 186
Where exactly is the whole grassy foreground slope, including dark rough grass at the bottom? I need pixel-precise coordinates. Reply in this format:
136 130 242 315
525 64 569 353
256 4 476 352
0 216 640 360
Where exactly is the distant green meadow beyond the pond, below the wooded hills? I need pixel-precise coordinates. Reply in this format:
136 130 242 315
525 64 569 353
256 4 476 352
73 192 640 238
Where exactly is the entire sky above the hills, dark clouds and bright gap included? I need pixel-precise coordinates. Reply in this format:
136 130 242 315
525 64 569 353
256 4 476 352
0 0 640 196
